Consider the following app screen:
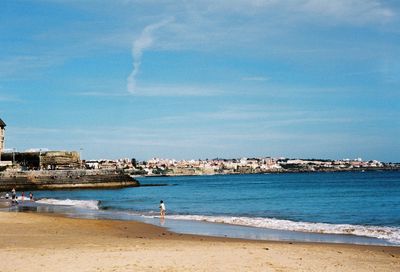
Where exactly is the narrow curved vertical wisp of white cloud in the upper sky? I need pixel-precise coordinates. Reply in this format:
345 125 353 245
127 18 173 94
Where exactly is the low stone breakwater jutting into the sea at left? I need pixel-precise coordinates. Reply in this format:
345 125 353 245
0 170 140 191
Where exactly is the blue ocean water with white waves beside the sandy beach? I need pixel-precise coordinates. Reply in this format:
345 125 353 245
3 171 400 246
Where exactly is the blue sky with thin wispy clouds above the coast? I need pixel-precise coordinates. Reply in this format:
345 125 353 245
0 0 400 162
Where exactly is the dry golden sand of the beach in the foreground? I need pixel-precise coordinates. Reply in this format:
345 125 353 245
0 212 400 271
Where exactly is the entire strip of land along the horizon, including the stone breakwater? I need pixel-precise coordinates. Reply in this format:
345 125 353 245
0 150 400 191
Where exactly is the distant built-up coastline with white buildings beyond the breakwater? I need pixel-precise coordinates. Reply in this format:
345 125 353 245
131 158 400 176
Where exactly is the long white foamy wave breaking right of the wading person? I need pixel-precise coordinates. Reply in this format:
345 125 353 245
168 215 400 244
